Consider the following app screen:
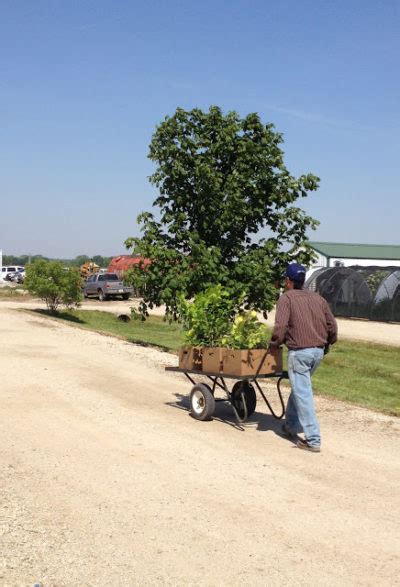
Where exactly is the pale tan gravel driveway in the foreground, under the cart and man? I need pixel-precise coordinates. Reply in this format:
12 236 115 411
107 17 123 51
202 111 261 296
0 305 400 587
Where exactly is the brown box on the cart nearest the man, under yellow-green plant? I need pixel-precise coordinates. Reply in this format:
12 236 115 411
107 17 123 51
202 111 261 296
222 349 282 375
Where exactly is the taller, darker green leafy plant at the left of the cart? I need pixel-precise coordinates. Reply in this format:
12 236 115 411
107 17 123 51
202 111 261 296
178 285 242 347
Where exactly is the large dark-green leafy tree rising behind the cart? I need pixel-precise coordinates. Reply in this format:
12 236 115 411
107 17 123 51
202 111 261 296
125 106 319 316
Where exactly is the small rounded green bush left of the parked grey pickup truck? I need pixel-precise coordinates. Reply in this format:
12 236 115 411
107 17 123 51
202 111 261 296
24 259 82 312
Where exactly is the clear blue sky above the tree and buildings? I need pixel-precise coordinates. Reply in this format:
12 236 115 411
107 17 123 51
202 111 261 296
0 0 400 257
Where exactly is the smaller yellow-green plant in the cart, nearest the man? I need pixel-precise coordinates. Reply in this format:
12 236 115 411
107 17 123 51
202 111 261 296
221 310 270 349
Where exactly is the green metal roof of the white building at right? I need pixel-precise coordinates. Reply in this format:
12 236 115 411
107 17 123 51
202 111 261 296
310 241 400 260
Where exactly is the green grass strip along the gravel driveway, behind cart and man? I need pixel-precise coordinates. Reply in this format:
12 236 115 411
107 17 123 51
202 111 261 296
32 310 400 416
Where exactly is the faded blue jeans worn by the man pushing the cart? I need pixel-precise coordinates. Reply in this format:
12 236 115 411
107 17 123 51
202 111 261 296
286 347 324 446
